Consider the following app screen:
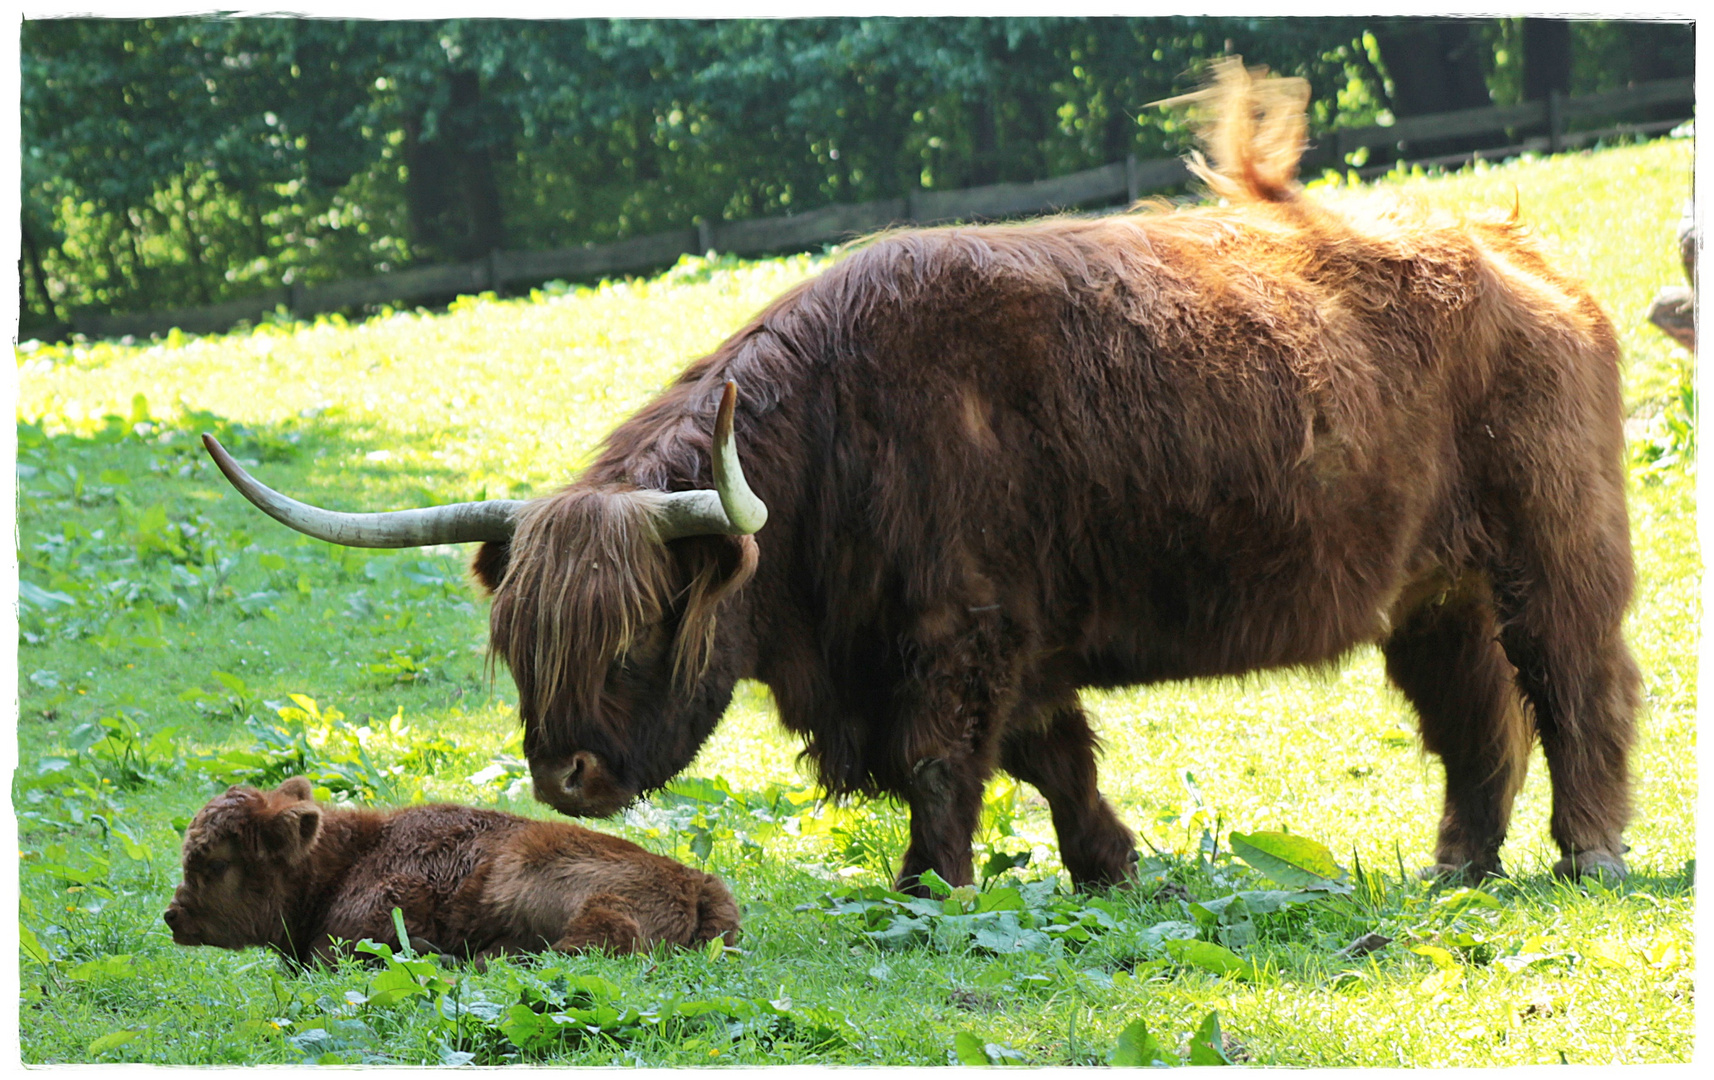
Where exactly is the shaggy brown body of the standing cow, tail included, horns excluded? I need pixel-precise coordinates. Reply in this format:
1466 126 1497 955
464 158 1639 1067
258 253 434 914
476 57 1639 883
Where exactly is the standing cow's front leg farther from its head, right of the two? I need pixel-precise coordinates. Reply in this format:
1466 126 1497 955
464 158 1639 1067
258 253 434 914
999 701 1136 888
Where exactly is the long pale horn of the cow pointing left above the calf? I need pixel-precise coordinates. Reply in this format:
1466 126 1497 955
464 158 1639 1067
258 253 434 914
202 435 523 547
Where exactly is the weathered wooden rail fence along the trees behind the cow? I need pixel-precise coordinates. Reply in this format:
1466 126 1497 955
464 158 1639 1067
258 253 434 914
72 79 1695 338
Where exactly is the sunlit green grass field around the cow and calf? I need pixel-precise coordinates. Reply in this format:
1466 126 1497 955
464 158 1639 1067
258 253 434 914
12 141 1700 1066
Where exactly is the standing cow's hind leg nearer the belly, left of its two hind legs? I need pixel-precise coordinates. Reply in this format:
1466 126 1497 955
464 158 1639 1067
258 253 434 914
1383 581 1529 879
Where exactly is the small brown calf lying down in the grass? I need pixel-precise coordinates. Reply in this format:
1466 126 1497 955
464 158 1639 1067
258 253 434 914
163 778 739 963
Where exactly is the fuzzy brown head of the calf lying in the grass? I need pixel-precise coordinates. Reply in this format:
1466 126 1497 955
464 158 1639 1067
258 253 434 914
161 777 321 948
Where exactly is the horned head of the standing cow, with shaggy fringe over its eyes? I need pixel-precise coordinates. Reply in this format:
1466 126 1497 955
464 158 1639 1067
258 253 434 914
204 382 768 816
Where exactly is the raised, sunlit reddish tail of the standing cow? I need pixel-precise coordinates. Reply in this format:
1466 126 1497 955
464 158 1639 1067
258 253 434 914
1155 57 1309 202
